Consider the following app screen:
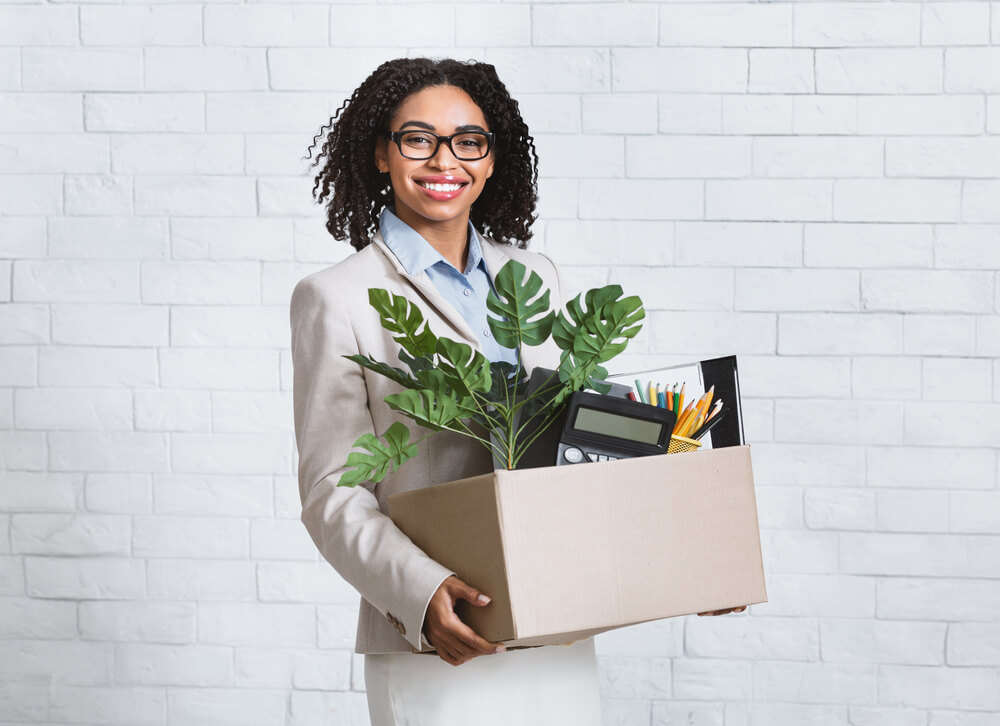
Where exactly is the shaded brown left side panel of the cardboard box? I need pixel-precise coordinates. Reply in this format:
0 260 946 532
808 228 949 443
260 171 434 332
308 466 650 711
389 474 514 642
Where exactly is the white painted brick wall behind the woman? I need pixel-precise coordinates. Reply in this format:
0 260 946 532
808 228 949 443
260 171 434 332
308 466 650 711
0 0 1000 726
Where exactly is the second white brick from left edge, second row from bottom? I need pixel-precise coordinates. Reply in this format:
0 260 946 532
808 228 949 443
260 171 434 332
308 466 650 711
115 643 233 686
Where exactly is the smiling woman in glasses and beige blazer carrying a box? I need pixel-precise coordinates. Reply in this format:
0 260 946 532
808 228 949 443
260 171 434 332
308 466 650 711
291 59 600 726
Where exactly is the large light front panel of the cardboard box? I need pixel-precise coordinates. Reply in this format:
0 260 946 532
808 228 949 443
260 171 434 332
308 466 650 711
497 446 766 640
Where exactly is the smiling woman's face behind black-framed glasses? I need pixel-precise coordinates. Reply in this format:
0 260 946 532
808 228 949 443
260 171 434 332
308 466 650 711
375 86 493 231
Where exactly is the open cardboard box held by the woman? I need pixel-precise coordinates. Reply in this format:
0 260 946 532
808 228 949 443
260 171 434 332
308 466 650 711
389 446 767 646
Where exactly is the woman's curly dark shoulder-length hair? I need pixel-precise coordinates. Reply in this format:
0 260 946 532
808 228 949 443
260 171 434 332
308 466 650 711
307 58 538 250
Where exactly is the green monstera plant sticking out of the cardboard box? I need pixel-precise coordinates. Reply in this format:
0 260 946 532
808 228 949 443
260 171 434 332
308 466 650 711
338 260 645 486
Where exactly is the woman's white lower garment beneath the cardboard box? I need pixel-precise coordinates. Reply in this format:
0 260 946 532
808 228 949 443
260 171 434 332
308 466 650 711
365 638 601 726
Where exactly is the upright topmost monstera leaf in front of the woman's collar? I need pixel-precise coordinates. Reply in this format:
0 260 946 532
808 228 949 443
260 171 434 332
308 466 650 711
486 260 555 348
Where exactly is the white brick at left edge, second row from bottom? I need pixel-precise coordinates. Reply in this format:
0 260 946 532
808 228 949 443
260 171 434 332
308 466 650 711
0 640 113 691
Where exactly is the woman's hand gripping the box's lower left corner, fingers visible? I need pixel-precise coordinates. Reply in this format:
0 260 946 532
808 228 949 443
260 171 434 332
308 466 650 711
424 575 506 665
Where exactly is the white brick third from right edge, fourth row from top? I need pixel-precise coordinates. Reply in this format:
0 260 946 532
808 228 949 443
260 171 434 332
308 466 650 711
625 136 750 179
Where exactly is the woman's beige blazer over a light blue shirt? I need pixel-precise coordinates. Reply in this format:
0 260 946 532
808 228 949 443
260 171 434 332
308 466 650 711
290 234 563 653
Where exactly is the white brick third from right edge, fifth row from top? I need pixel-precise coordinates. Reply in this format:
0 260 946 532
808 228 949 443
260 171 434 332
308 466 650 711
705 179 833 221
